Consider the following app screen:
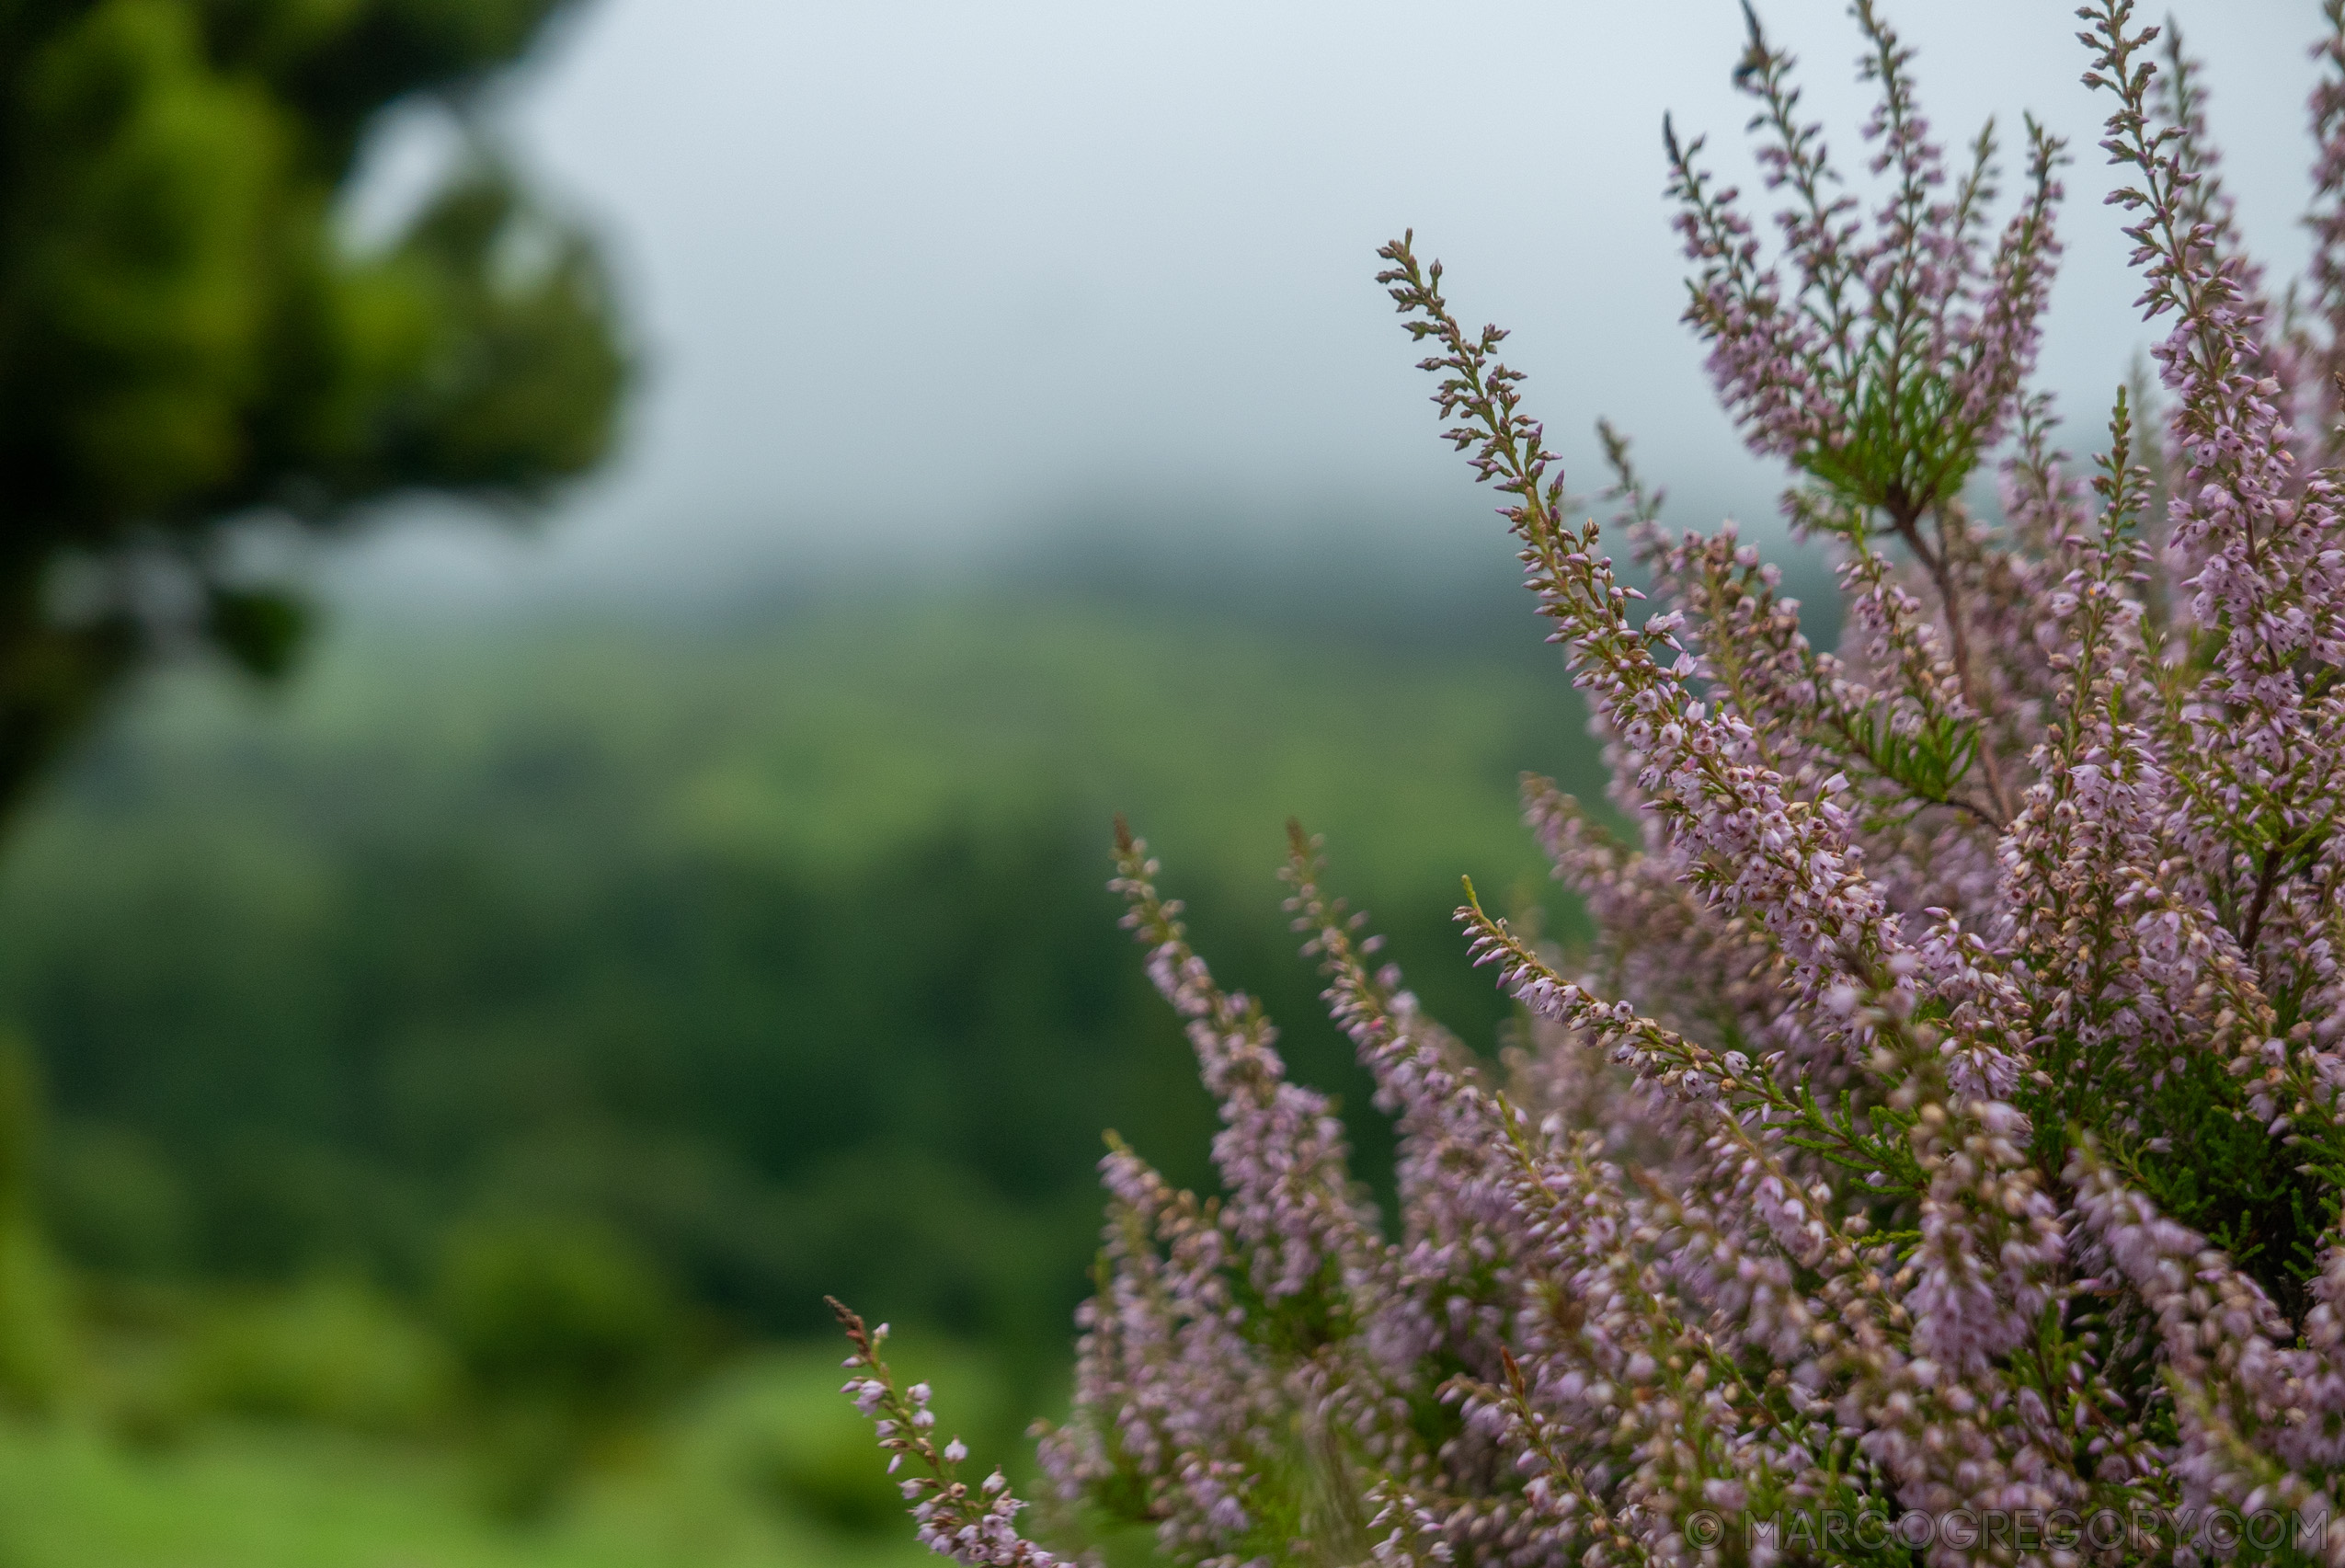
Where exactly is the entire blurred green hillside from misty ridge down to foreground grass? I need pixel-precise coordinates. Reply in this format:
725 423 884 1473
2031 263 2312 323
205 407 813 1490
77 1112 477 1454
0 589 1597 1568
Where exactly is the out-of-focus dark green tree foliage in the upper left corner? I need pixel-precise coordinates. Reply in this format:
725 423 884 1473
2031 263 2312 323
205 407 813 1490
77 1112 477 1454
0 0 623 808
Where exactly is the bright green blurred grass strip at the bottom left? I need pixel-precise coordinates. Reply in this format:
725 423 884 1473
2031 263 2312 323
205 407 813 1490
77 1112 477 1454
0 1347 970 1568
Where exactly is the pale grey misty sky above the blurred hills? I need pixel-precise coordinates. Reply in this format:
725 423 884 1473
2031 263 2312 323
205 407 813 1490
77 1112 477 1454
335 0 2319 598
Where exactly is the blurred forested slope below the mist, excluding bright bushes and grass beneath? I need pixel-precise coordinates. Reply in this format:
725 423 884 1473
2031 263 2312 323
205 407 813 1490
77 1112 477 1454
0 586 1642 1357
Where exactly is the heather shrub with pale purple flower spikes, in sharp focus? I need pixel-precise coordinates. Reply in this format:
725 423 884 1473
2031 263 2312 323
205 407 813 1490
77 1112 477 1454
841 0 2345 1568
